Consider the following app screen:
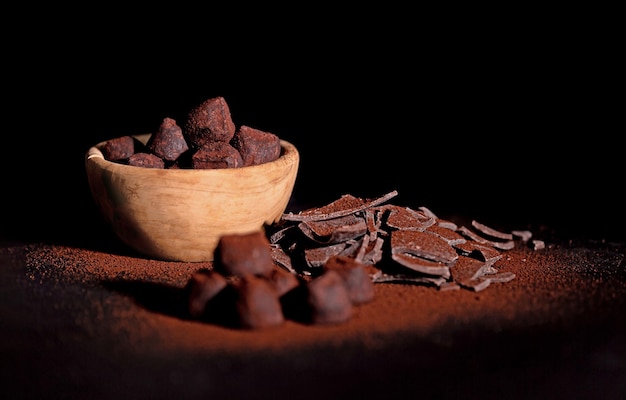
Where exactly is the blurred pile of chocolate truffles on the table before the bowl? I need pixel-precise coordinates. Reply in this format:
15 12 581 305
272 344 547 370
185 230 374 329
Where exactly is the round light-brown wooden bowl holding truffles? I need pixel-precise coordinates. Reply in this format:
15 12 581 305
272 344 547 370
85 134 300 262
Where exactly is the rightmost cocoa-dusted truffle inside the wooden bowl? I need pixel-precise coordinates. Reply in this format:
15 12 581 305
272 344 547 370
230 125 282 167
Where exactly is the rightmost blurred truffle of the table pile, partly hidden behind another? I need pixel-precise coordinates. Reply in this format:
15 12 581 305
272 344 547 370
324 256 374 304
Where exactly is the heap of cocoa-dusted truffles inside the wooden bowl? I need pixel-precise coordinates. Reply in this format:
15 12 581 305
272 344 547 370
102 97 282 169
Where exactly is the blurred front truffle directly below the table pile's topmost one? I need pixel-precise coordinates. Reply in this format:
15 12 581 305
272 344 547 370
233 275 285 329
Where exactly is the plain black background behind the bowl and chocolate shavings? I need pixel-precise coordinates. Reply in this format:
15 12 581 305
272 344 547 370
0 10 626 244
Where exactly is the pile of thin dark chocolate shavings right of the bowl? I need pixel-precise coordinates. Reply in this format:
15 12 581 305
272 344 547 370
267 191 545 291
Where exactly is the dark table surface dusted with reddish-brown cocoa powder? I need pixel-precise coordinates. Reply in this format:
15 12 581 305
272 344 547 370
0 222 626 399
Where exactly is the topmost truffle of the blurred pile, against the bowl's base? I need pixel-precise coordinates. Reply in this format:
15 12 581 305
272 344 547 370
214 230 274 276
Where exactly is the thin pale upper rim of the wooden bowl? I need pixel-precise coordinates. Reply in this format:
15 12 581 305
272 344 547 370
85 133 300 175
